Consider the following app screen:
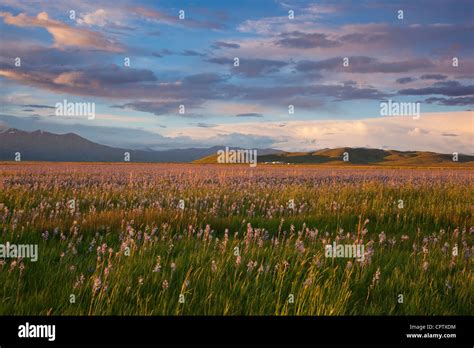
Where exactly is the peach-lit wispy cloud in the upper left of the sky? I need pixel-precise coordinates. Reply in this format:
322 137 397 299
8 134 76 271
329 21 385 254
0 12 123 52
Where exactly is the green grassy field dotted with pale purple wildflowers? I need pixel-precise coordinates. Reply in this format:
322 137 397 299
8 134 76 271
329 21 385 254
0 163 474 315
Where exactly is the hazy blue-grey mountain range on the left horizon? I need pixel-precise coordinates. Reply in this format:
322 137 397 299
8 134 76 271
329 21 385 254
0 128 278 163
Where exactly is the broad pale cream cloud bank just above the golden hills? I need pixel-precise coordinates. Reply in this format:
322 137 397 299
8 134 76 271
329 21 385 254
167 112 474 154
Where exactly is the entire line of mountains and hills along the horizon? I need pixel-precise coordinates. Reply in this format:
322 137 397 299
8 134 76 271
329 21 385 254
0 128 474 166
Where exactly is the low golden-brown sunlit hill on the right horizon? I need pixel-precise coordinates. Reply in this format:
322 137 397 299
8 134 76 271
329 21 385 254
193 147 474 166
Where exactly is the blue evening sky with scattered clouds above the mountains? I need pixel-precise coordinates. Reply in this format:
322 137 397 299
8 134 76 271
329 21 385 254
0 0 474 154
